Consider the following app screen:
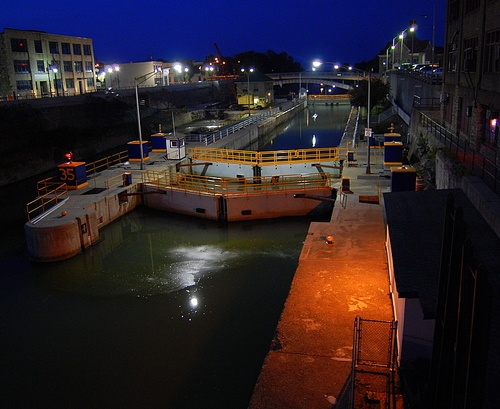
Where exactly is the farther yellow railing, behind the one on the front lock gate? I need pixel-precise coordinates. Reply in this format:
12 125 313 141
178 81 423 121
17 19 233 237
188 147 345 165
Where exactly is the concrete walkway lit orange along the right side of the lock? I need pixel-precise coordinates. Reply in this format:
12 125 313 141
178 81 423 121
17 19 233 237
249 111 400 409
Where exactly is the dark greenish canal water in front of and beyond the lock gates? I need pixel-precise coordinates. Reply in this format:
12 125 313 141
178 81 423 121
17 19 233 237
0 103 348 409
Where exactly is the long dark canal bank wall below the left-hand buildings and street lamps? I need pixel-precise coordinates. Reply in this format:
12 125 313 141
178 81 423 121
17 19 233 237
0 84 230 186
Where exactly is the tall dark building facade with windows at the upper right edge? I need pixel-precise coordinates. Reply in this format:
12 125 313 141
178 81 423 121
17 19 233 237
442 0 500 166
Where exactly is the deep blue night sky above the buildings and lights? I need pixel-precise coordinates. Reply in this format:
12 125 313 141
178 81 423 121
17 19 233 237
0 0 446 68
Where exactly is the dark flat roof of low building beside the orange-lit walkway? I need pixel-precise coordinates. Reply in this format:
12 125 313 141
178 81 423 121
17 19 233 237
384 189 500 318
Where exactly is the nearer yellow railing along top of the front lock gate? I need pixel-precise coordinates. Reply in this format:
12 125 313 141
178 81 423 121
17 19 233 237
143 171 331 197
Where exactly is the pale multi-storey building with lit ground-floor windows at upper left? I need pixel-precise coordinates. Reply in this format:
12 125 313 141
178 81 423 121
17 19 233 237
0 28 96 99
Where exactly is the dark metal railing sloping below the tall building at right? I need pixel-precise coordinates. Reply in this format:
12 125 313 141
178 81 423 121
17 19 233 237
419 112 500 194
